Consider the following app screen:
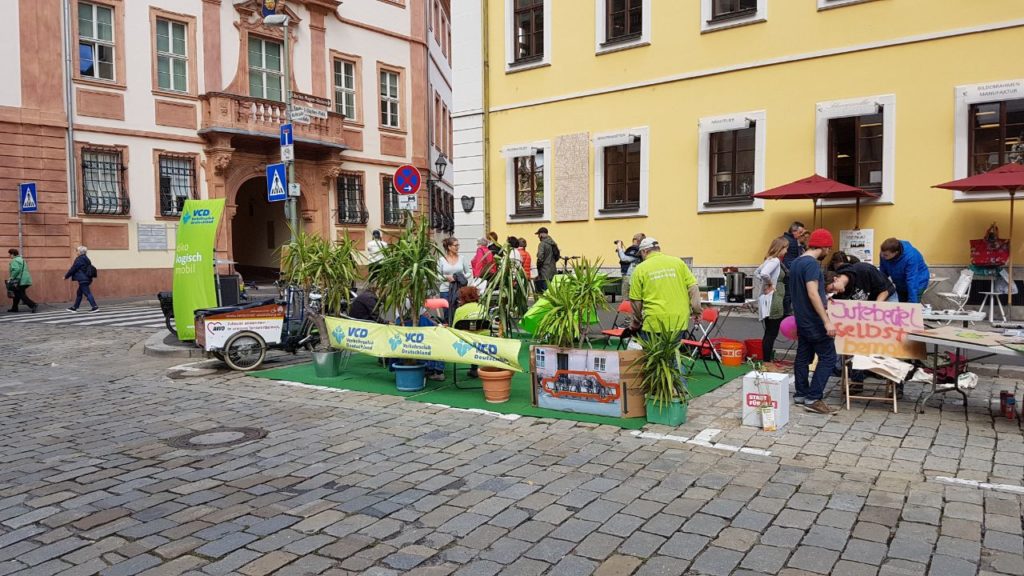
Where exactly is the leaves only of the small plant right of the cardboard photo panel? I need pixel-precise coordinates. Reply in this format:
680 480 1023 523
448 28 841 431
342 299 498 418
634 317 692 410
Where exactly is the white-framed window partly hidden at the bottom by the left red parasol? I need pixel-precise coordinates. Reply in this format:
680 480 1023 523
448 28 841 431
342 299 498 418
814 94 896 204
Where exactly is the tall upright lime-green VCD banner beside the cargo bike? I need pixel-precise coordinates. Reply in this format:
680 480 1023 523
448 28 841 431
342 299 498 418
173 198 224 340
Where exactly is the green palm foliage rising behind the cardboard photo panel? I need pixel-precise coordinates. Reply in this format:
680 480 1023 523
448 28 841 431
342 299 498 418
537 258 608 347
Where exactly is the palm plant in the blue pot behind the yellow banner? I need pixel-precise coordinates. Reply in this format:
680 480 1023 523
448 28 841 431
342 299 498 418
370 213 441 392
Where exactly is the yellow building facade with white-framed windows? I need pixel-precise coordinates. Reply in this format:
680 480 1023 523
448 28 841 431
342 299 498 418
464 0 1024 276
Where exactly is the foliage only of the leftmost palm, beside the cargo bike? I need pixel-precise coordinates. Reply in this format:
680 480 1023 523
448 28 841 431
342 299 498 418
281 226 359 314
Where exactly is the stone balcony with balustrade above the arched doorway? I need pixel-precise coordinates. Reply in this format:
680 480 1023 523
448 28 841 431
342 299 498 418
200 92 345 148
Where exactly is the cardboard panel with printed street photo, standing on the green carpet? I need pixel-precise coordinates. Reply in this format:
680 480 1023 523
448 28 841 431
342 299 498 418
529 346 646 418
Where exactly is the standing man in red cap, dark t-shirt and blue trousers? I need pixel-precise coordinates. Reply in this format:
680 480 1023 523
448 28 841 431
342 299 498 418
790 229 836 414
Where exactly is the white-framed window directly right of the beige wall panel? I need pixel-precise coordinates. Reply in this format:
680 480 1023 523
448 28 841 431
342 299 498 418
593 128 650 218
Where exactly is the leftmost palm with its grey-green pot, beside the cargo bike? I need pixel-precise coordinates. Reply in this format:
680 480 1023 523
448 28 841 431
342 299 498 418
281 232 359 377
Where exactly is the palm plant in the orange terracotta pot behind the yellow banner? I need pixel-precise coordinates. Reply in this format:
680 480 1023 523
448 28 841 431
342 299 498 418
478 244 531 404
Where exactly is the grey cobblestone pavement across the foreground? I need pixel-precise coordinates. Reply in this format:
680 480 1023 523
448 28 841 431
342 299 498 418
0 325 1024 576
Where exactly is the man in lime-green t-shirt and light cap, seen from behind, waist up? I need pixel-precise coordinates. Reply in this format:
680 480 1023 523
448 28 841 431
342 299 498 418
630 238 700 332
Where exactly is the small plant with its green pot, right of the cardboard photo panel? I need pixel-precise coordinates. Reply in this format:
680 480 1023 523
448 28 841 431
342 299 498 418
636 319 691 426
